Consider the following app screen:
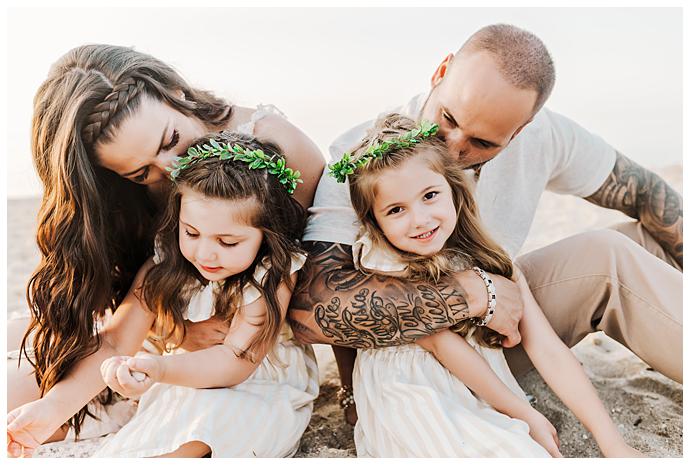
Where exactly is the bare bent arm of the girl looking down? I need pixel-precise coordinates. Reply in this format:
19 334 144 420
128 273 297 388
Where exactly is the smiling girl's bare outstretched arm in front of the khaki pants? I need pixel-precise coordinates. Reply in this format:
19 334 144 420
518 271 633 457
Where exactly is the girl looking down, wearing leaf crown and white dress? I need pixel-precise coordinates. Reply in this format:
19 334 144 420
10 133 318 457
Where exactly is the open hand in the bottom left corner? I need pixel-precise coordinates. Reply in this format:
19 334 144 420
7 397 62 457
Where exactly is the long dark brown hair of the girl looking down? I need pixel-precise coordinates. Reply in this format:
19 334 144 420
143 132 306 361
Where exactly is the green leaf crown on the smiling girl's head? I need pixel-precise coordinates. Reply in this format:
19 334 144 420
328 121 438 182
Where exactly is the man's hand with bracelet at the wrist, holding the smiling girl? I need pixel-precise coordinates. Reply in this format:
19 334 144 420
458 271 523 348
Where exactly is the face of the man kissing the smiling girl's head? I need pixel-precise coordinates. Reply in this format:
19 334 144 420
422 52 537 168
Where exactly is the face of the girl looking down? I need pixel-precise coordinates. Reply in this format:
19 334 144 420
180 187 263 281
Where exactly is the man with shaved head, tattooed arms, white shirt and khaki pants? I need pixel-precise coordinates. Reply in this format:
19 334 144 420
289 24 683 418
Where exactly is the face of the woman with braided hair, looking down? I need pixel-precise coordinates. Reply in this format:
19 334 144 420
95 95 207 185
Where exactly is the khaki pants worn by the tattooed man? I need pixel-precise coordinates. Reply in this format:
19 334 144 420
498 222 683 383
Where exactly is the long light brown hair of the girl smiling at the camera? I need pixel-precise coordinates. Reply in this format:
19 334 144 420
348 113 513 347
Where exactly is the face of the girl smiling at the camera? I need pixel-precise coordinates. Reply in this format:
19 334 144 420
374 155 457 255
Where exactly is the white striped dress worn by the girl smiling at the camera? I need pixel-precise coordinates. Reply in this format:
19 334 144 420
353 232 550 457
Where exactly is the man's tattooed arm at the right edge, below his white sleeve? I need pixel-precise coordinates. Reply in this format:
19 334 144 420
586 153 683 268
